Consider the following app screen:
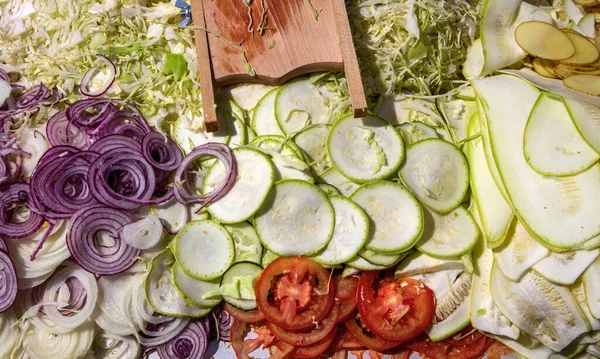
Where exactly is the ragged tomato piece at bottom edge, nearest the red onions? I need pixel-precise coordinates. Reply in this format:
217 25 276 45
230 319 275 359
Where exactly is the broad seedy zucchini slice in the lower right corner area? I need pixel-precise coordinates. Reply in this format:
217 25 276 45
491 264 588 351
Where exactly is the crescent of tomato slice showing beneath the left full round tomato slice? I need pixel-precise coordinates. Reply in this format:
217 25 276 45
267 304 340 347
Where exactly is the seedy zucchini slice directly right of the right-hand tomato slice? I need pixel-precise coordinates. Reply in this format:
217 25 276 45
425 272 473 342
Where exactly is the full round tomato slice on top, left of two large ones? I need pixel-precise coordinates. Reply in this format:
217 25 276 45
256 257 335 330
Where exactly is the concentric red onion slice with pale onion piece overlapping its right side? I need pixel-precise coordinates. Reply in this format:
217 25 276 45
67 205 141 276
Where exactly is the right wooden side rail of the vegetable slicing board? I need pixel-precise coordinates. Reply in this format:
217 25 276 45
332 0 368 117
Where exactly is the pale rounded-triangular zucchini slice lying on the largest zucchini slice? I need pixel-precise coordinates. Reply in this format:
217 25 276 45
523 93 600 176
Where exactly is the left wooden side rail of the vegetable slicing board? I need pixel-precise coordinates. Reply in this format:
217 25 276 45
191 0 219 132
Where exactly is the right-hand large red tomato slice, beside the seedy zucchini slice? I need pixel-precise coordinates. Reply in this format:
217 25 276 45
357 272 435 342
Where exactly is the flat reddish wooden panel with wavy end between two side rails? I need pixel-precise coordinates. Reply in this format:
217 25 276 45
203 0 344 86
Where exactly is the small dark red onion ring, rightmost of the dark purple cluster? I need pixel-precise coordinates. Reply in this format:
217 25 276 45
142 132 183 172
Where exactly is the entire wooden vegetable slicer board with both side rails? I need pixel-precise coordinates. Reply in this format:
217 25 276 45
191 0 367 132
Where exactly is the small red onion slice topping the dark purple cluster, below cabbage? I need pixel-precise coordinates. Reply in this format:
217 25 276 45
67 98 117 129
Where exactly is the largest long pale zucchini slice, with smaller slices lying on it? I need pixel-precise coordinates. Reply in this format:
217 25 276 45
473 75 600 250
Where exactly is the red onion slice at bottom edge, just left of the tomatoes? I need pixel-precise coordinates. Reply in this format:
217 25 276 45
156 317 209 359
